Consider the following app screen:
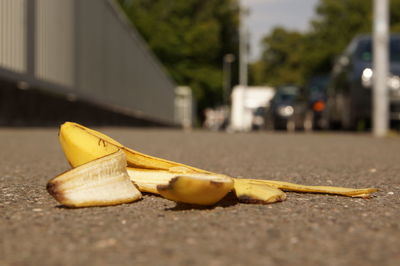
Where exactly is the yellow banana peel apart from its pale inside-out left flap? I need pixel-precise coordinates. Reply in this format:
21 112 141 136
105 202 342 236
52 122 377 205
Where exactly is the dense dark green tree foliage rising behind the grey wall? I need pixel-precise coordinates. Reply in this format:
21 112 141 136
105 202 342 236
119 0 238 113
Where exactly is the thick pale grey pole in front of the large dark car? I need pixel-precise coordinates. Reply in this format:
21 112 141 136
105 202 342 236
373 0 389 137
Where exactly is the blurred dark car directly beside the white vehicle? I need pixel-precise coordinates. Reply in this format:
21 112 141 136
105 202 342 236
266 85 307 131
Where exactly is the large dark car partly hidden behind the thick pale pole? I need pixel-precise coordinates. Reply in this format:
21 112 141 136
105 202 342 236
325 35 400 129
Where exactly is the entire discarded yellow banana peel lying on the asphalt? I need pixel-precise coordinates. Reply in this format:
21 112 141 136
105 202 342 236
48 122 377 206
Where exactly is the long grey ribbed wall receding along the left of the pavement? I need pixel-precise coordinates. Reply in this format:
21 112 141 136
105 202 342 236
0 0 175 124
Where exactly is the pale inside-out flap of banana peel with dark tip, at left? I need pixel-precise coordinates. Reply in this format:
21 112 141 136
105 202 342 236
46 151 142 207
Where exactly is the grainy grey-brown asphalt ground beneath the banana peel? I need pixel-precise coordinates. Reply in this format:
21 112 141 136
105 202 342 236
0 128 400 266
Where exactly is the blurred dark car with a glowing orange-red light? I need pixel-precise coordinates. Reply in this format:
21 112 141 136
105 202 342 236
304 74 329 130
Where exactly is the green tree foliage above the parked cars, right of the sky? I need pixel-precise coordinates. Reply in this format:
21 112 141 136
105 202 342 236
255 0 400 85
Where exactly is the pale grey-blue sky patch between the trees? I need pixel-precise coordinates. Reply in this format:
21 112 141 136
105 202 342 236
241 0 318 61
